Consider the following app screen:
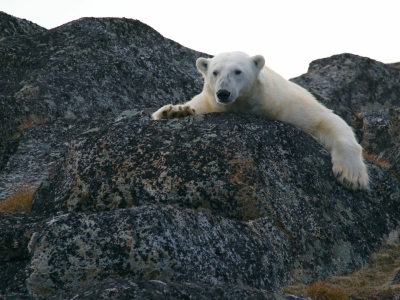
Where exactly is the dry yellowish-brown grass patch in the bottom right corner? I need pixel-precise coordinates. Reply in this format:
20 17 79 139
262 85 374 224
283 241 400 300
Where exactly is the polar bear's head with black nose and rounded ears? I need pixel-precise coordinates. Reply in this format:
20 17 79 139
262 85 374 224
196 52 265 104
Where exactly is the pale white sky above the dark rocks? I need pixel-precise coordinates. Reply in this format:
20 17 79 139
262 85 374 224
0 0 400 79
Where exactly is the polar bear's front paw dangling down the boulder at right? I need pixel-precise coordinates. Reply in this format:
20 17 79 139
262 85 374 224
332 158 369 190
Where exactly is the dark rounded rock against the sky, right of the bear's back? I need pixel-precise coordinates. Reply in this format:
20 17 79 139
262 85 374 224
291 53 400 124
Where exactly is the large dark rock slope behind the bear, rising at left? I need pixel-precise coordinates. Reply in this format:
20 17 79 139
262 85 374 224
0 14 208 199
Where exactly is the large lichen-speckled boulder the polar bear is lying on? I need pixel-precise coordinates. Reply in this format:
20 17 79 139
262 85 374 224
26 114 400 291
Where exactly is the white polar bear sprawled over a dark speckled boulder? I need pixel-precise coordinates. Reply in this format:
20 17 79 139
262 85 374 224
152 52 369 190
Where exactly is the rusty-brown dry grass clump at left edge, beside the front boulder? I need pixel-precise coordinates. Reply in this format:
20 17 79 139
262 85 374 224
0 185 36 213
